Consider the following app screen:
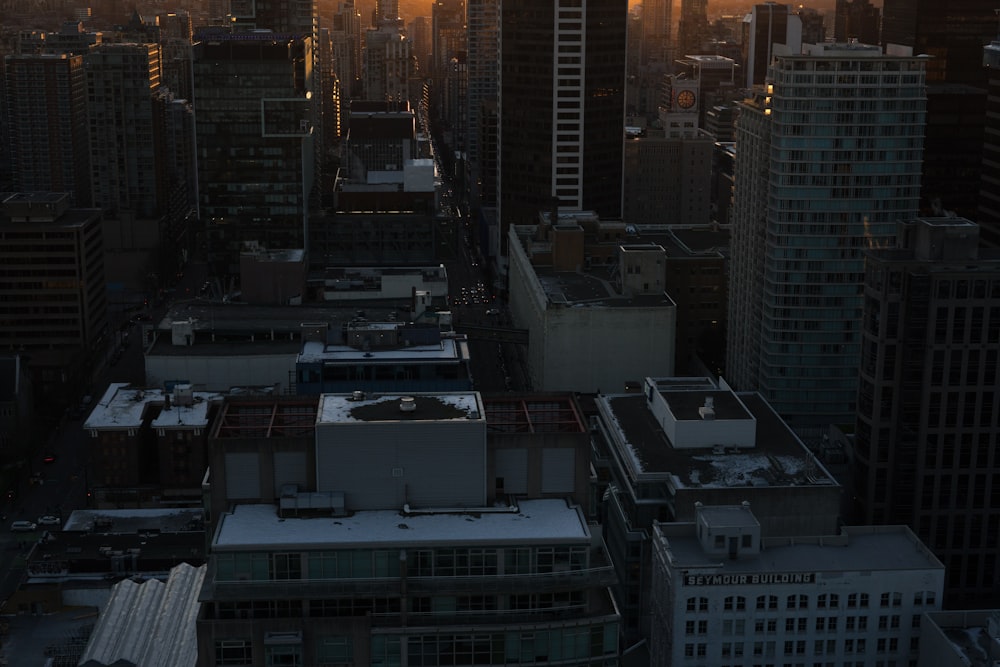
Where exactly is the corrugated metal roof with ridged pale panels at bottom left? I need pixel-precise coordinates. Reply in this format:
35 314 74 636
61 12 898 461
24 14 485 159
79 563 206 667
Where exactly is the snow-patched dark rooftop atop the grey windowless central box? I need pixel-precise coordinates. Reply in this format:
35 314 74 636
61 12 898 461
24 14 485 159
316 391 484 425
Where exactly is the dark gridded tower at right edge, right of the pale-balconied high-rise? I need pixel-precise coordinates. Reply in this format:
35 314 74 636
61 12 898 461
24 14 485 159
853 218 1000 607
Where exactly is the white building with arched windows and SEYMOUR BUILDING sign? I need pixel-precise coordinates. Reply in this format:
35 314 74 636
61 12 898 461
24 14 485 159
650 503 944 667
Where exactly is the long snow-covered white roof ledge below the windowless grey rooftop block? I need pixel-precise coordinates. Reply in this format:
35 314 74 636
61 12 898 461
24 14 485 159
212 499 590 551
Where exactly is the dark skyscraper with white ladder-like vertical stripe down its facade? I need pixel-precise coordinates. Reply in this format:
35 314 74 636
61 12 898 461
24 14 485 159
499 0 627 237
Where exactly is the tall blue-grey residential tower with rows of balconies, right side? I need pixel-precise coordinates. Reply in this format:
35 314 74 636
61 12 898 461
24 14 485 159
726 44 926 427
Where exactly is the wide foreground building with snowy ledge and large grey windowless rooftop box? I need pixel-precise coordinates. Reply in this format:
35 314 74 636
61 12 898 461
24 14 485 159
198 392 619 667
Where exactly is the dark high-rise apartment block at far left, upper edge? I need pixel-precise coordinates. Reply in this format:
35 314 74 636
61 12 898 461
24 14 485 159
6 53 91 206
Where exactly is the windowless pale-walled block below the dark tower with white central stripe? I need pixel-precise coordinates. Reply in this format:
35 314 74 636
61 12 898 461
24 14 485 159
509 213 677 393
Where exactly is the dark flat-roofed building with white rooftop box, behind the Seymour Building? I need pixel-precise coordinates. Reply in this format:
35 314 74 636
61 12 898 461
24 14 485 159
594 377 844 640
